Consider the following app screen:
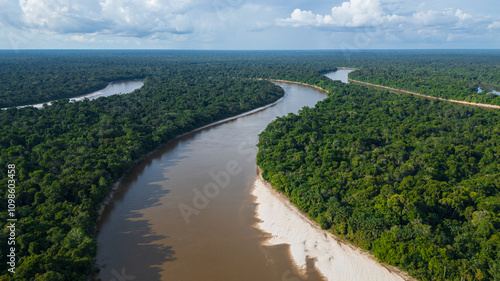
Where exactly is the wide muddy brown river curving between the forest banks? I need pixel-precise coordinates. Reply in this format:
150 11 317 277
96 79 336 281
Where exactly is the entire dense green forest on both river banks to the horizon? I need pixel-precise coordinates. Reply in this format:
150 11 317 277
0 51 500 280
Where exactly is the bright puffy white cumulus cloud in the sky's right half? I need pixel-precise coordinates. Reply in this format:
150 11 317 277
276 0 500 41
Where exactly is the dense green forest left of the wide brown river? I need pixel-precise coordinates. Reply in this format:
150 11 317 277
0 51 348 280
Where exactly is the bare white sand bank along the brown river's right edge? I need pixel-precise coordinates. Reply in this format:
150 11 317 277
252 176 413 281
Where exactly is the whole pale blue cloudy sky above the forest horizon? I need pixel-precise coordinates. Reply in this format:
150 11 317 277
0 0 500 50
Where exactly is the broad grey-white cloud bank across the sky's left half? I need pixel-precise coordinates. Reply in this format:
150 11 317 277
5 0 275 45
